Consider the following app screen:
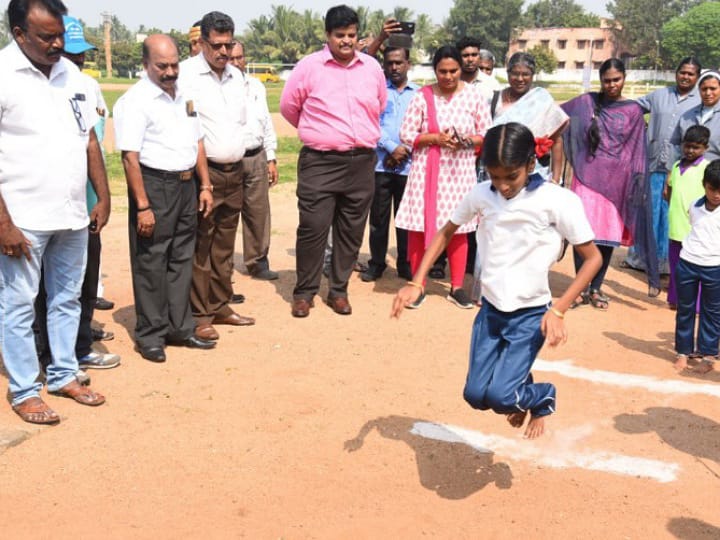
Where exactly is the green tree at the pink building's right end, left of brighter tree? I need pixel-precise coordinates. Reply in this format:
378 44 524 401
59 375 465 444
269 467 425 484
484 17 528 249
607 0 701 68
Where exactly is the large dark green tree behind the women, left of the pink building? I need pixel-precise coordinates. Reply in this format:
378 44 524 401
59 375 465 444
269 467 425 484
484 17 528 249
444 0 523 62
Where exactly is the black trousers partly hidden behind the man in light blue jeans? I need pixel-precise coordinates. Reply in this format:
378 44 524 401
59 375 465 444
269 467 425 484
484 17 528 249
33 226 102 368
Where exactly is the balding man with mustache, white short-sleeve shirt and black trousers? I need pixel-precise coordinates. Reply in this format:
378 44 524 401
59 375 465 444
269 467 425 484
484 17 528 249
113 34 215 362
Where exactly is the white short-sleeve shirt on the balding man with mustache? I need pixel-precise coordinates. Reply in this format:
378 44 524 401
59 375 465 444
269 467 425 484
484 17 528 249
113 79 202 171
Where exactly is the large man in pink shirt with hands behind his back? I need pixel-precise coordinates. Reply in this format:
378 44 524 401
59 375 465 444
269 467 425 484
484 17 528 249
280 5 387 317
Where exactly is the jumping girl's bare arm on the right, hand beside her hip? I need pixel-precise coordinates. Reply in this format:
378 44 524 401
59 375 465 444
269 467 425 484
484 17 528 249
540 242 602 347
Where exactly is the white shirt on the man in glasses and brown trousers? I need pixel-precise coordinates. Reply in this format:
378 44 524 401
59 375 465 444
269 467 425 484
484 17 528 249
178 53 247 163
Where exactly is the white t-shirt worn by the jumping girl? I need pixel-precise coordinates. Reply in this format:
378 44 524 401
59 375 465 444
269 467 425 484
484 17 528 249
451 179 595 312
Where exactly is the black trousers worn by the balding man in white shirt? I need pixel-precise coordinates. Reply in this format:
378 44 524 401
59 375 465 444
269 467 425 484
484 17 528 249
128 170 198 348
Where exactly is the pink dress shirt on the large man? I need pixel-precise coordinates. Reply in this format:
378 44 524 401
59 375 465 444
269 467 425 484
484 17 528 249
280 45 387 151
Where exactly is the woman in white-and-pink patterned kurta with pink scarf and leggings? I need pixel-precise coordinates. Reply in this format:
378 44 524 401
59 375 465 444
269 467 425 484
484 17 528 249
395 46 491 308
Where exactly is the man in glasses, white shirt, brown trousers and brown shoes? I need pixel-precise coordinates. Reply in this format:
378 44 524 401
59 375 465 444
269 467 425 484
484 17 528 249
179 11 255 340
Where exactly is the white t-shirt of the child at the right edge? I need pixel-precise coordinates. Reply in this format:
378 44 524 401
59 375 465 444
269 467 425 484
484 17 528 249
680 197 720 266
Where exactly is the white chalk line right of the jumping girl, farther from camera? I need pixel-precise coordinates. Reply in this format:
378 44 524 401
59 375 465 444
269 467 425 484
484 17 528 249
532 359 720 398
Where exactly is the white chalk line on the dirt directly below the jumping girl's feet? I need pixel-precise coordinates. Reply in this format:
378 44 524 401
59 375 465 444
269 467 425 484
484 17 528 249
410 422 680 483
